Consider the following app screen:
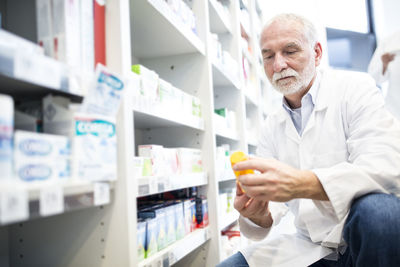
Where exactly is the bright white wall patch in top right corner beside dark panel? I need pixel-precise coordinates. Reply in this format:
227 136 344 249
372 0 400 43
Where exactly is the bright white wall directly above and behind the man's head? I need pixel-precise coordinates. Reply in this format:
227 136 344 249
260 0 329 66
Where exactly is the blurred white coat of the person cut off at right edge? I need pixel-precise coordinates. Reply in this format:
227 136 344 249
368 31 400 119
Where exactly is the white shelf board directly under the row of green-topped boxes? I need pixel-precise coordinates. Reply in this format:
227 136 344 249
134 107 204 131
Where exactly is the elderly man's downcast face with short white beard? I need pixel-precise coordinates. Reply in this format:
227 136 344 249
261 22 319 95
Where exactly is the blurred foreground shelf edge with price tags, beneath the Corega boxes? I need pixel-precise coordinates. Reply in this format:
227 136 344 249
0 180 114 228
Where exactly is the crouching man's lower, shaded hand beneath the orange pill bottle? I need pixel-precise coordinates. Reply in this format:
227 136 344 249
234 182 273 228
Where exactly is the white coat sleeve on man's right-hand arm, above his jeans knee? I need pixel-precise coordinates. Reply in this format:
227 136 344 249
313 74 400 224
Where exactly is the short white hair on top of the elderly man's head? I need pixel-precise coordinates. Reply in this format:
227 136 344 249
263 13 318 46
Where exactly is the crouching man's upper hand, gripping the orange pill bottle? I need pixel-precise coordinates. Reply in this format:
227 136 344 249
233 157 329 202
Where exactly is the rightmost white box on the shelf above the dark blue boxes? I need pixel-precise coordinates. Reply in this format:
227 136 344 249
177 148 203 174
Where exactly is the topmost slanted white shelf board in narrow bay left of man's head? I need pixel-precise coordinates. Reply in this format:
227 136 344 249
209 0 231 33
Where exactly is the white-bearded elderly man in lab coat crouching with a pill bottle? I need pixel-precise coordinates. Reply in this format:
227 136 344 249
218 14 400 267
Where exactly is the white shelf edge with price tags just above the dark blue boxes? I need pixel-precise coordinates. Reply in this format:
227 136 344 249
138 173 208 197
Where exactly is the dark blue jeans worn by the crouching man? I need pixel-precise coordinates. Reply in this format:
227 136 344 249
218 194 400 267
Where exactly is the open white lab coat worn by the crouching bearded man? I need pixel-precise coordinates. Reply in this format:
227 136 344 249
239 70 400 267
